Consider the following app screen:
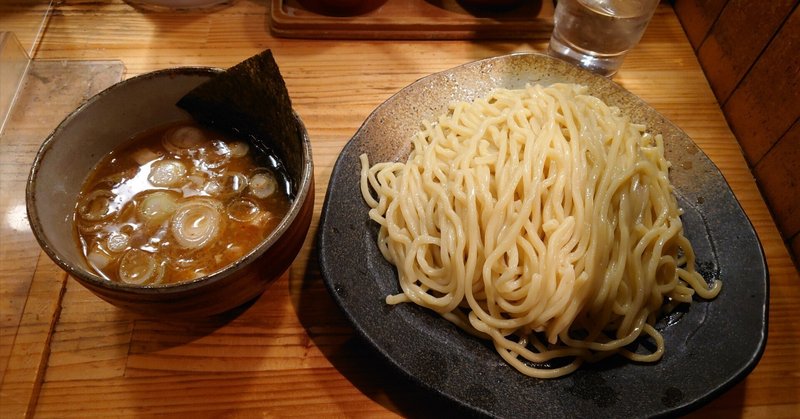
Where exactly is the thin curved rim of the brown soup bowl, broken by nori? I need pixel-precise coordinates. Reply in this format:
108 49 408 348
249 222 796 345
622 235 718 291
25 66 314 295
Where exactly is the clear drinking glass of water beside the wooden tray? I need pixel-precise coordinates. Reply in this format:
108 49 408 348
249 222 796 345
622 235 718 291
549 0 659 77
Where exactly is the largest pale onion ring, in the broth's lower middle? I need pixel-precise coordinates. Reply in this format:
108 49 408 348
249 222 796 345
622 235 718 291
170 199 222 249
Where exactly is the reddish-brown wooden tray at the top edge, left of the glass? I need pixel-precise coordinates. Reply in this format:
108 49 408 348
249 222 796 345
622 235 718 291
270 0 553 39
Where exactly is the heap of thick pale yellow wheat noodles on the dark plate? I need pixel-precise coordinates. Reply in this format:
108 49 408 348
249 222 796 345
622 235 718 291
361 84 720 378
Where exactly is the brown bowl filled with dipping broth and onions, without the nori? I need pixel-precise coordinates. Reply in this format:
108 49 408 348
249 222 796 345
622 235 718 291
26 67 314 317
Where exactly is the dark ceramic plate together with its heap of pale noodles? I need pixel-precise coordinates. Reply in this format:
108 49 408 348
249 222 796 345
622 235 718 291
318 53 768 417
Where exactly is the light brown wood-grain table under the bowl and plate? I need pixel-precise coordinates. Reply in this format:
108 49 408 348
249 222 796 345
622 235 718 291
0 0 800 419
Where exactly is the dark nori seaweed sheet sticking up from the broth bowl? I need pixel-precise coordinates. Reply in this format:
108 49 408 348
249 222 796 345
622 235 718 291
177 50 303 196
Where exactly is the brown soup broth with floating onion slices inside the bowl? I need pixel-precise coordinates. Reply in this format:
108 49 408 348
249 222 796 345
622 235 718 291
75 121 290 286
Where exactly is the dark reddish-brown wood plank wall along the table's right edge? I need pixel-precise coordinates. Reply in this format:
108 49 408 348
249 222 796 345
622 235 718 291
673 0 800 262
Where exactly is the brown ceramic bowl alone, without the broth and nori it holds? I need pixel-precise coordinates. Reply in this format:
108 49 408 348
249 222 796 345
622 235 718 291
26 68 314 317
